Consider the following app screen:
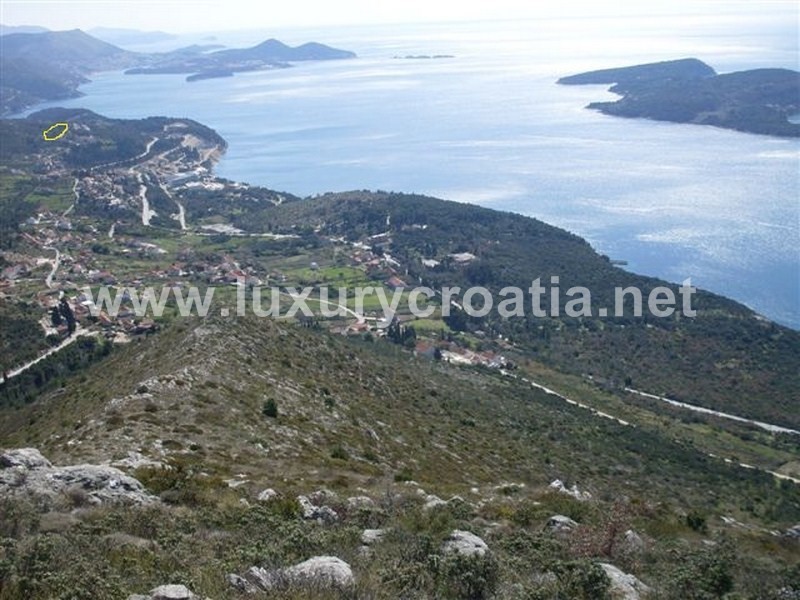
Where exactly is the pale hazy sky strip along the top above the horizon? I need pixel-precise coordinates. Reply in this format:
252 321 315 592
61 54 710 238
0 0 797 33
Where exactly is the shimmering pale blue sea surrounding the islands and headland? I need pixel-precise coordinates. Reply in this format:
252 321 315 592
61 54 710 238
25 11 800 328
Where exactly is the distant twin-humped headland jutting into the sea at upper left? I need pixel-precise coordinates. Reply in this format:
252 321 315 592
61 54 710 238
126 39 356 81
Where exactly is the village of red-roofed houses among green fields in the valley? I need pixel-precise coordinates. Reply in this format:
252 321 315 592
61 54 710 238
0 198 507 368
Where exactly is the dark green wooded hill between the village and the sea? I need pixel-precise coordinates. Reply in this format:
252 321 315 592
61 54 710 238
262 193 800 428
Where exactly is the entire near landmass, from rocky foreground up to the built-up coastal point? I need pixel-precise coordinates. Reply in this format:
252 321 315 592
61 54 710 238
0 109 800 600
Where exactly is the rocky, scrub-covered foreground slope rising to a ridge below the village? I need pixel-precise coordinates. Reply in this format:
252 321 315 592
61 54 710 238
0 318 800 599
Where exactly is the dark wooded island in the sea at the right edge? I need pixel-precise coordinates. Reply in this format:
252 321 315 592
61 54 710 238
558 58 800 137
